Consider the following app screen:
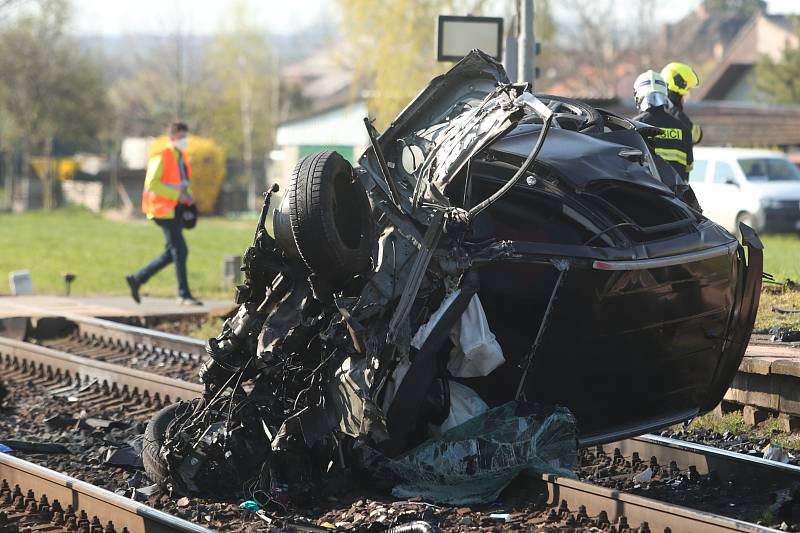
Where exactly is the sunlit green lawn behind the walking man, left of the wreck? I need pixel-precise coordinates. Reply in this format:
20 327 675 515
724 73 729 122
0 208 255 298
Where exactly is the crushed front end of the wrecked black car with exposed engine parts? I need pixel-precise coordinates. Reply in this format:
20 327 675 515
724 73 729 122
144 52 576 505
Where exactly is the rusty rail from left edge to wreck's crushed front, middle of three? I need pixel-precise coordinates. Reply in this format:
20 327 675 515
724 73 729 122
0 337 204 401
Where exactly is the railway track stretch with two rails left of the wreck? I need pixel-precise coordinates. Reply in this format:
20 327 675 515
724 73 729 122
0 316 205 418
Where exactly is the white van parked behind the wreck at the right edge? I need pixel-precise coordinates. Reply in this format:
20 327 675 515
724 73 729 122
689 148 800 234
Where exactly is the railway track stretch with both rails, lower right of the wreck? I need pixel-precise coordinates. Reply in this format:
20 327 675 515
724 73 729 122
568 435 800 532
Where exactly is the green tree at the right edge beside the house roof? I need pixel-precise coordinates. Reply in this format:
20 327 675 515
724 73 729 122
755 19 800 104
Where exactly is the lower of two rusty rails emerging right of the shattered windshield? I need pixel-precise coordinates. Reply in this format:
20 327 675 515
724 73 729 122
542 474 778 533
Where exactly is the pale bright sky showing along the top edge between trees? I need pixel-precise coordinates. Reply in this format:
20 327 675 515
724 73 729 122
74 0 800 35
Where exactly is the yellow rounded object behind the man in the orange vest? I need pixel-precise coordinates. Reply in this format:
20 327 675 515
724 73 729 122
147 135 225 215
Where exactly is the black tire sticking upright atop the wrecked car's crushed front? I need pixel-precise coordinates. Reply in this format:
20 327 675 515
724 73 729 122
289 150 373 282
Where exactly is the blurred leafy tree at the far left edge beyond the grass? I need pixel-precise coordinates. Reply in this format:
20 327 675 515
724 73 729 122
0 0 108 207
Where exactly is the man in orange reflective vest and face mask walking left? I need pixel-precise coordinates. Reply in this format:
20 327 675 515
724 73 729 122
125 122 202 305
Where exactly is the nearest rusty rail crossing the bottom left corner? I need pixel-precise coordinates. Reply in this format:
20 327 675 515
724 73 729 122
0 454 211 533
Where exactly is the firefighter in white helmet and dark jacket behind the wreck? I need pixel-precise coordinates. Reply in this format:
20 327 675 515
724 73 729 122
633 70 694 182
